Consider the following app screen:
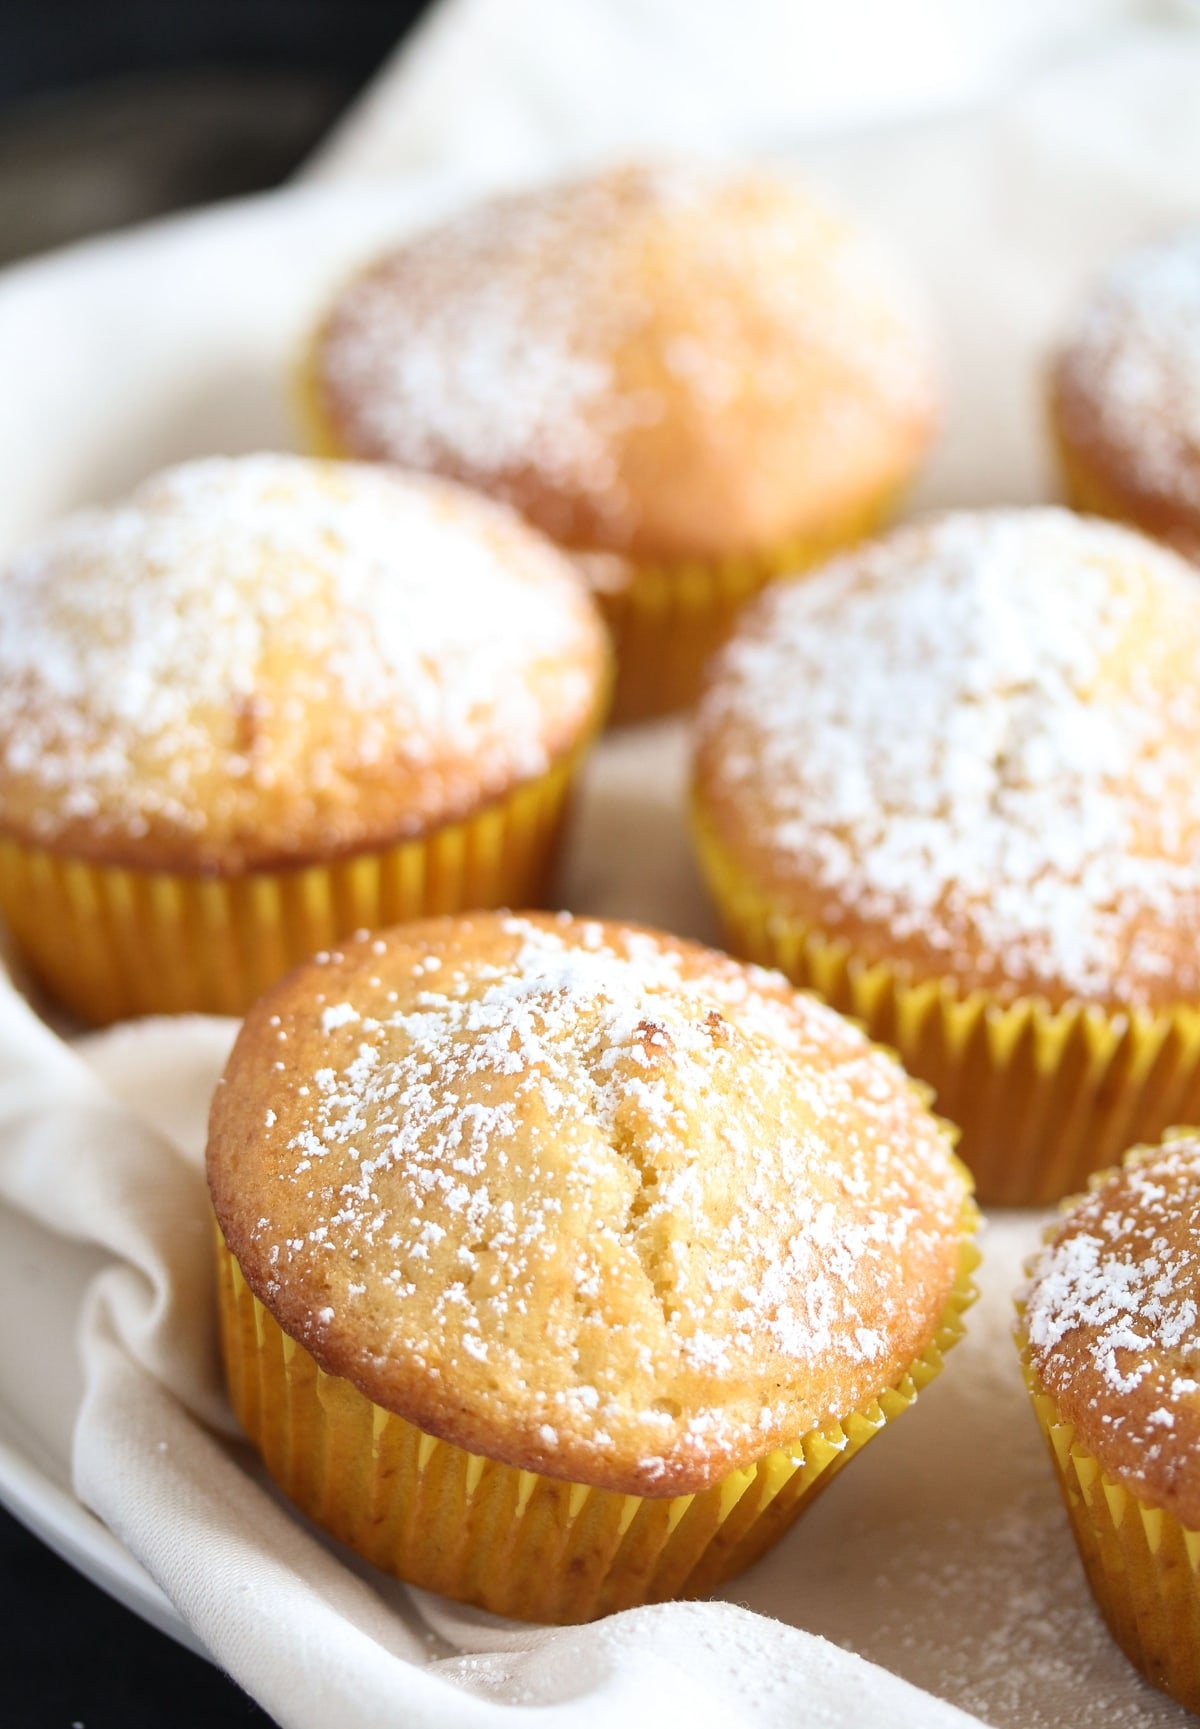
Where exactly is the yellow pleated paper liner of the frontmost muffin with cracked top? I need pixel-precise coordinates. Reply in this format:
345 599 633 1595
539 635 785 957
216 1200 979 1624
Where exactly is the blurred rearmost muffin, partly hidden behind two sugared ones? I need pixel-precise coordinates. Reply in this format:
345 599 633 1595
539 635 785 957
303 166 937 719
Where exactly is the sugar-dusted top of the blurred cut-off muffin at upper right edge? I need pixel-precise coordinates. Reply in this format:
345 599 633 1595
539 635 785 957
1058 230 1200 510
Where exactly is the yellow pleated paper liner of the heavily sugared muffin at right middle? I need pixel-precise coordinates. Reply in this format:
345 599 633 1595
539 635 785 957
693 807 1200 1207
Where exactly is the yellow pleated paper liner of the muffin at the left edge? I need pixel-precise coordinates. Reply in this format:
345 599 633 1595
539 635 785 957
0 749 583 1024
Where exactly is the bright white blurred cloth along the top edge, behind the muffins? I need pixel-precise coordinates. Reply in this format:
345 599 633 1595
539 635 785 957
310 0 1141 178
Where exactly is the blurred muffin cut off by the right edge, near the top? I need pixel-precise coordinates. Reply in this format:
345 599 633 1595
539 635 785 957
1050 228 1200 558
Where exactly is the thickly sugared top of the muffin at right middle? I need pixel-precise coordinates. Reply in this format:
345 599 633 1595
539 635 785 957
695 510 1200 1008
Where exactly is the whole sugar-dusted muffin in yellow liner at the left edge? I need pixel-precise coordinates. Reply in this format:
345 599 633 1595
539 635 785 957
0 456 609 1022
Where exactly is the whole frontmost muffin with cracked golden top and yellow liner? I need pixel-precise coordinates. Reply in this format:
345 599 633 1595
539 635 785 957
207 913 973 1622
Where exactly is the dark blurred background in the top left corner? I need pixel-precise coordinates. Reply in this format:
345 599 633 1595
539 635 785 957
0 0 427 263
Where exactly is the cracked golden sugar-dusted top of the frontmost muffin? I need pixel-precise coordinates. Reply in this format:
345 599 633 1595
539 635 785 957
207 915 967 1496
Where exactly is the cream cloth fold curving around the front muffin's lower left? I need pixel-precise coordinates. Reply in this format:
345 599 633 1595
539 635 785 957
0 984 989 1729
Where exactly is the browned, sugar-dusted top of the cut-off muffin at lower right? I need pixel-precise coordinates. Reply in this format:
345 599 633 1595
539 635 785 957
1022 1129 1200 1530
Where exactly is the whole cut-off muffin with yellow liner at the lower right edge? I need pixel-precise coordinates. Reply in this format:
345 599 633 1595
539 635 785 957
1017 1129 1200 1712
